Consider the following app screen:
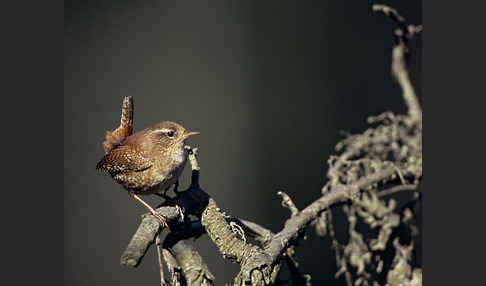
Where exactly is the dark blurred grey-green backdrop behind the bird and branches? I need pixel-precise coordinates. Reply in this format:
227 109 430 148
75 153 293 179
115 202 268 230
64 0 422 285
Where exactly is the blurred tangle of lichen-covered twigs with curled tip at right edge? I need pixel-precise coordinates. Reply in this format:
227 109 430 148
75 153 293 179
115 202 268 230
314 5 422 285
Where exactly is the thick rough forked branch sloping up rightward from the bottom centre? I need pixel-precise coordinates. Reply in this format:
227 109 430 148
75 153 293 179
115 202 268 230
121 142 402 285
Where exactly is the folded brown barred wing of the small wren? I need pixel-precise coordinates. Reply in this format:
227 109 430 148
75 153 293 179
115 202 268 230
96 145 153 175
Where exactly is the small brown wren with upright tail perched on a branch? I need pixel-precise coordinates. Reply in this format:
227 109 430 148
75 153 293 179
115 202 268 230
96 96 199 226
